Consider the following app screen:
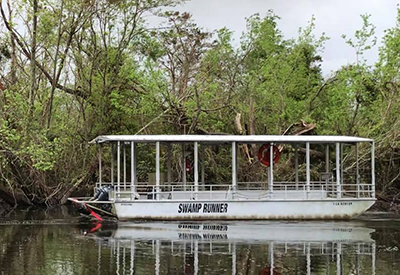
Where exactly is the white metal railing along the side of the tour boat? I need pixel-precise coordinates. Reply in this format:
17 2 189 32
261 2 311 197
102 181 373 201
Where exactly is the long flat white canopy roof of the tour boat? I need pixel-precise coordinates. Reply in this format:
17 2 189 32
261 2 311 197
90 135 373 144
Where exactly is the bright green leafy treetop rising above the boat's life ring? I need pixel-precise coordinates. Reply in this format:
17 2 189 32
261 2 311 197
236 12 328 134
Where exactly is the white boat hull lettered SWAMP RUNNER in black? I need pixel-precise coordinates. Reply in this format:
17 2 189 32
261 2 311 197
114 198 375 220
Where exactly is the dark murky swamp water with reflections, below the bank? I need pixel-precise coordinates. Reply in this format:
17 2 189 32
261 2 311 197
0 208 400 275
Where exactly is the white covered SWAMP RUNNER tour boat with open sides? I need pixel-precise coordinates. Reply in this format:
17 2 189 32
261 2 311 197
69 135 376 220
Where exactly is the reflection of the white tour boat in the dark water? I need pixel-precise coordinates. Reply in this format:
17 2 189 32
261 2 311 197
84 221 376 274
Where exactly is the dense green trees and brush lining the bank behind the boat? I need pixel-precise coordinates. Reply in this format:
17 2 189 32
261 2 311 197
0 0 400 211
